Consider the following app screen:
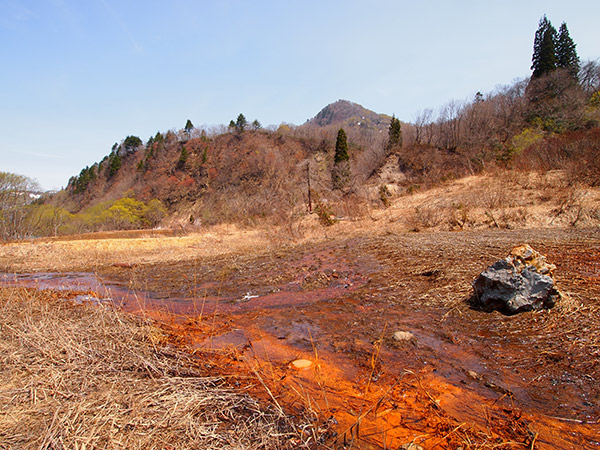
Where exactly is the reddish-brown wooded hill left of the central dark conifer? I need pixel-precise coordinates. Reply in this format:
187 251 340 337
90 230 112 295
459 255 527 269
65 129 327 224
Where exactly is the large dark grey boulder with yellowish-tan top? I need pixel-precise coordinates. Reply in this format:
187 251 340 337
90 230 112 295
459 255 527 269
473 245 560 314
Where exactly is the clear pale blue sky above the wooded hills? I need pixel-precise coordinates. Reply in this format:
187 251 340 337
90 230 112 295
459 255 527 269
0 0 600 189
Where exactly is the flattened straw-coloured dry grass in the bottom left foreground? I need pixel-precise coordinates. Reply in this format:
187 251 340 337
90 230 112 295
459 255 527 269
0 288 310 449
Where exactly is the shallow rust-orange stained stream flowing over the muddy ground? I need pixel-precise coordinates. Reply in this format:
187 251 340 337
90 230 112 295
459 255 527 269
0 234 600 450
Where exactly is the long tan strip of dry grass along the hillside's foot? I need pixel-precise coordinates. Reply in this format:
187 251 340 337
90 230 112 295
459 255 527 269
0 171 600 272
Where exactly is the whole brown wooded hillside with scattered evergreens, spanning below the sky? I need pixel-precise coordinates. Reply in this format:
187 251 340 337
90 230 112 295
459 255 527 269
2 16 600 238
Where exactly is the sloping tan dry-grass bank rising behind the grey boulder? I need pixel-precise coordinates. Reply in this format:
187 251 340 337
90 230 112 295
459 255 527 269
373 171 600 231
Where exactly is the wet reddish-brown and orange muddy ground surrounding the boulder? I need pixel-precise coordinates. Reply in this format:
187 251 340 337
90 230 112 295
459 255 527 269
1 230 600 449
